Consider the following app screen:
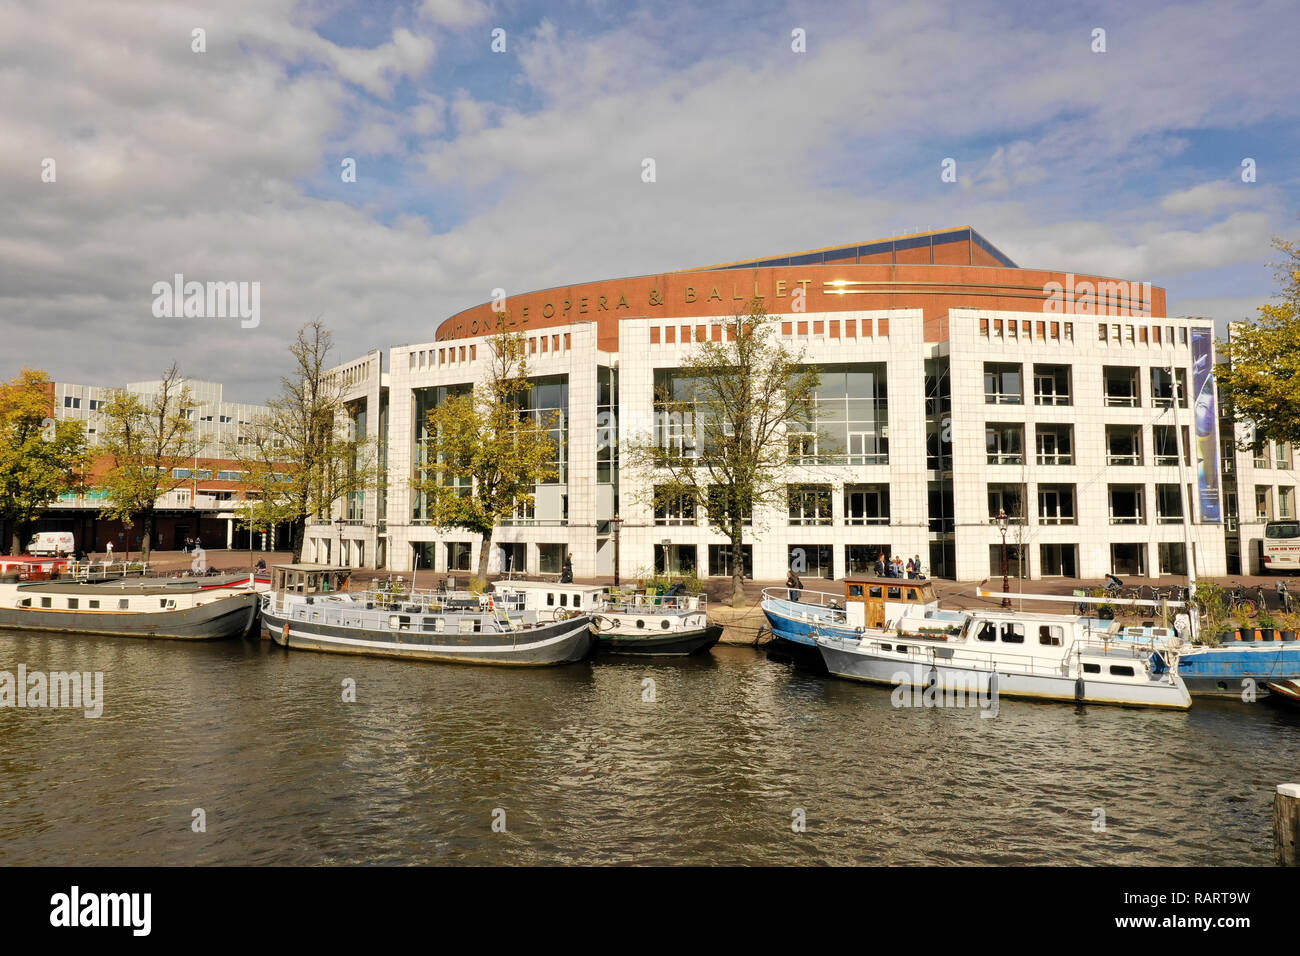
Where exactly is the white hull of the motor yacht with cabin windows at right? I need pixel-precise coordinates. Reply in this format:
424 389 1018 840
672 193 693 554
819 641 1192 710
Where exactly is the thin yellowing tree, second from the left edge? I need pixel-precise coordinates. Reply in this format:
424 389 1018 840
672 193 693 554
96 363 199 562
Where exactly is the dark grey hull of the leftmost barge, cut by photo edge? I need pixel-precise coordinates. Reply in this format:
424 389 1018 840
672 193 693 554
0 593 259 641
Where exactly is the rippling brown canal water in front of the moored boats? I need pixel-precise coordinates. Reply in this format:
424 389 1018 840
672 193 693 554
0 633 1300 865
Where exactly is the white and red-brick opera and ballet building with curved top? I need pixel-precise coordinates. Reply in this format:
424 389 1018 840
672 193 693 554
304 226 1296 580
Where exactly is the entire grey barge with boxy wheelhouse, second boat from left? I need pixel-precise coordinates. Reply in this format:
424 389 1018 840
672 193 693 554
261 564 595 667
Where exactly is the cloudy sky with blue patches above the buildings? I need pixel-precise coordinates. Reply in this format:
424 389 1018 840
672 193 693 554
0 0 1300 402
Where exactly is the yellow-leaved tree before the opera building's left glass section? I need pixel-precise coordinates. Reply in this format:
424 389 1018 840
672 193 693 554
412 325 562 584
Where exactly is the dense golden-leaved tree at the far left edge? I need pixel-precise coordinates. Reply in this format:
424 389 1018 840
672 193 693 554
0 368 86 554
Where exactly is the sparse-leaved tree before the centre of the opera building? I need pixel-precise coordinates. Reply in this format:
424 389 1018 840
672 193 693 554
625 298 820 606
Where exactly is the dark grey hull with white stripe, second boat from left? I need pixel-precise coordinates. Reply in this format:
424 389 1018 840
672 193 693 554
263 609 595 667
